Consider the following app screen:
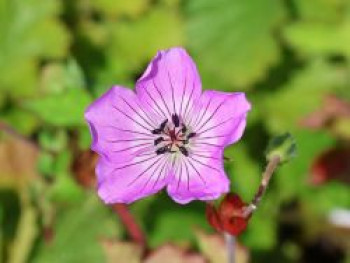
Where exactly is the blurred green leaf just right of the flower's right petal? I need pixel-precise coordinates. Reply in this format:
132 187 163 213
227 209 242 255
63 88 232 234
258 60 347 133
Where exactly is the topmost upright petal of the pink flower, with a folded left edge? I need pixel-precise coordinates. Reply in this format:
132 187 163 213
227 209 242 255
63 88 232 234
136 48 201 120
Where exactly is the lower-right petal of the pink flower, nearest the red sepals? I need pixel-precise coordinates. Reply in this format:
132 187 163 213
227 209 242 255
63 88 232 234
167 151 230 204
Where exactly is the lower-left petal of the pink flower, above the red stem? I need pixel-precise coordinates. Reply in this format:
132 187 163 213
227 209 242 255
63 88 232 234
96 154 170 204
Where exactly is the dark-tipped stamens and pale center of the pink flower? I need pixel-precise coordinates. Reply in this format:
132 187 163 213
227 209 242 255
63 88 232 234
152 114 196 156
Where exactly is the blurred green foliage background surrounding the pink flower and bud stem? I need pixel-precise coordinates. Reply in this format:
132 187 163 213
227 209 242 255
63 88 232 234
0 0 350 263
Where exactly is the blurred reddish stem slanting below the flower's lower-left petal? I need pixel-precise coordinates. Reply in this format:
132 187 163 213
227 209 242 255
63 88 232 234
112 204 146 247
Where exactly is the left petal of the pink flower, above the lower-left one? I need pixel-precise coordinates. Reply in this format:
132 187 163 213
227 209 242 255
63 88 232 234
85 86 156 162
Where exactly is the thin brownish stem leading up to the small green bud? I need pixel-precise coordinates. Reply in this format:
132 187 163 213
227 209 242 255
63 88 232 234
244 156 281 217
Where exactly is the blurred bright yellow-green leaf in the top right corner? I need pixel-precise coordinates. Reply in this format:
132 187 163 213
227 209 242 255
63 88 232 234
282 0 350 57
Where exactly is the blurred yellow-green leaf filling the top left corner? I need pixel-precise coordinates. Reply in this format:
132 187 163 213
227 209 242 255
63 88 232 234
0 0 69 97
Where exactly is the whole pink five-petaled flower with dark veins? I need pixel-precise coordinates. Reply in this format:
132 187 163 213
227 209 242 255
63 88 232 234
85 48 250 204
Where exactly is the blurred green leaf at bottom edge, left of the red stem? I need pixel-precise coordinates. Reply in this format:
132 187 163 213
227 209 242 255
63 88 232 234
33 196 118 263
